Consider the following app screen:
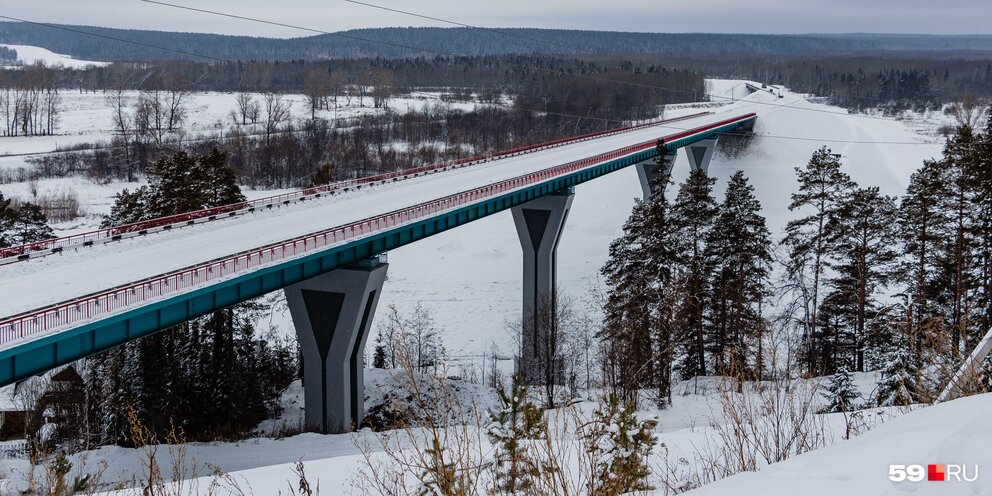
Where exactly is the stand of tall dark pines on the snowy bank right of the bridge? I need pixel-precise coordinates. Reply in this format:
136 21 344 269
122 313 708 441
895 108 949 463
599 122 992 408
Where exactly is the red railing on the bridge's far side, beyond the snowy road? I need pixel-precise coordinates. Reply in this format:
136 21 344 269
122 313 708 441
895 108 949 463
0 112 712 265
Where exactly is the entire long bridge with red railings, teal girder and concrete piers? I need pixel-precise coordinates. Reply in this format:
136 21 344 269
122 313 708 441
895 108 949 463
0 109 757 432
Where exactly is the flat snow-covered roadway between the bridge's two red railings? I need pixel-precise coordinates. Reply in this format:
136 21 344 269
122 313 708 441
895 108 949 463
0 109 739 316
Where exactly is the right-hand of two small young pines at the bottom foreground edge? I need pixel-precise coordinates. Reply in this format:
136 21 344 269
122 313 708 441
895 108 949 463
583 395 657 496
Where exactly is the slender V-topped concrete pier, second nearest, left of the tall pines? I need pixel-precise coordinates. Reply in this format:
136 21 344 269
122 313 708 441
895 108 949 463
512 189 574 384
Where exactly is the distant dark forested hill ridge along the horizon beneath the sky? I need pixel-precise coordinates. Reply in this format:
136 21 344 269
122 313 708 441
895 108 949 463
0 22 992 61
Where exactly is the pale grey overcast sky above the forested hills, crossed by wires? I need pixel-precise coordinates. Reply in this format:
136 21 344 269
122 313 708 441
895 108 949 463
7 0 992 37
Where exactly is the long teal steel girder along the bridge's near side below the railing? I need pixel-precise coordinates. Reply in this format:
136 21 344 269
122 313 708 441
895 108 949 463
0 114 757 386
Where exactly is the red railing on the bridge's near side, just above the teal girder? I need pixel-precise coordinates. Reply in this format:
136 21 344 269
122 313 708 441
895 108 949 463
0 114 754 345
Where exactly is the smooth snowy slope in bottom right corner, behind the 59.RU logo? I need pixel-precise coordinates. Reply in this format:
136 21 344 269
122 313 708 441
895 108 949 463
680 393 992 496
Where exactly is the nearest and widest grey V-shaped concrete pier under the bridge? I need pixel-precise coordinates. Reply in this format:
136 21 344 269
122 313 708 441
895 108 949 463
285 259 388 434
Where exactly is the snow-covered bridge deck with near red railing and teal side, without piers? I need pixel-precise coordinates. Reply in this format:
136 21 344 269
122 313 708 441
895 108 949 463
0 112 754 364
